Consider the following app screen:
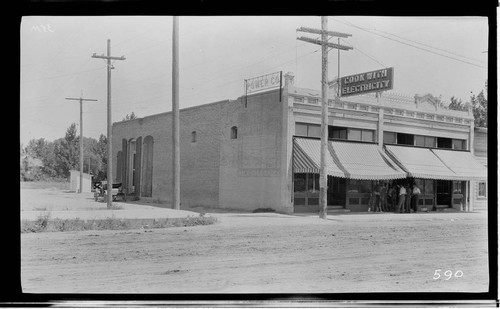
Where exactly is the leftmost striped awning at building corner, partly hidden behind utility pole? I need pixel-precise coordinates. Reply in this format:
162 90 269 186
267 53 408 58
293 138 345 177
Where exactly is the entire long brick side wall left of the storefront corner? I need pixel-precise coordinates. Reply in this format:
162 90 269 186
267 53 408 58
113 90 293 212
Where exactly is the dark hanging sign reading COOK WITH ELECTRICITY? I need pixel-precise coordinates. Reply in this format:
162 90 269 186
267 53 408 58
340 68 394 97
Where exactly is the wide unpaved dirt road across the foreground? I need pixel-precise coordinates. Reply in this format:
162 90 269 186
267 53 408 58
21 209 489 293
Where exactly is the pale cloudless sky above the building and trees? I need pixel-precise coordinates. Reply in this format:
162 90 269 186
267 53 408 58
20 16 488 145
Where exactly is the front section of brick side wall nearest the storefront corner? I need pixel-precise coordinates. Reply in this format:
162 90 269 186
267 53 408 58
219 91 292 212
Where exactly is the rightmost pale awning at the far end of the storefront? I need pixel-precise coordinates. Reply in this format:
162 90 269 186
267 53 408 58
431 149 488 180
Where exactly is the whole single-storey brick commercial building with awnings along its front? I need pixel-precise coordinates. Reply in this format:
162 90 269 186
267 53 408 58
112 73 486 213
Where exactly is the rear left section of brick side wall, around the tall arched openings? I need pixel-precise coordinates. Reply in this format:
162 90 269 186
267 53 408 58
113 101 227 207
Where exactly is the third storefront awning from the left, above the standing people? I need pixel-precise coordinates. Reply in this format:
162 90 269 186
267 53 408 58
386 145 462 180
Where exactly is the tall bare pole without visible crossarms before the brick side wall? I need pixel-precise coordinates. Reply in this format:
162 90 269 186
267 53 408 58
172 16 181 209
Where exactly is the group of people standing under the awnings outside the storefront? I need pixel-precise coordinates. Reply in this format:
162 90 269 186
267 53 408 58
368 181 421 213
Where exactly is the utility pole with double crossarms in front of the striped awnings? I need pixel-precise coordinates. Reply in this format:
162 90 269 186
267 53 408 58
297 16 352 219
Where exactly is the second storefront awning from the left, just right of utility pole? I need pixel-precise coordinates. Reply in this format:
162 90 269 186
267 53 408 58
328 141 407 180
